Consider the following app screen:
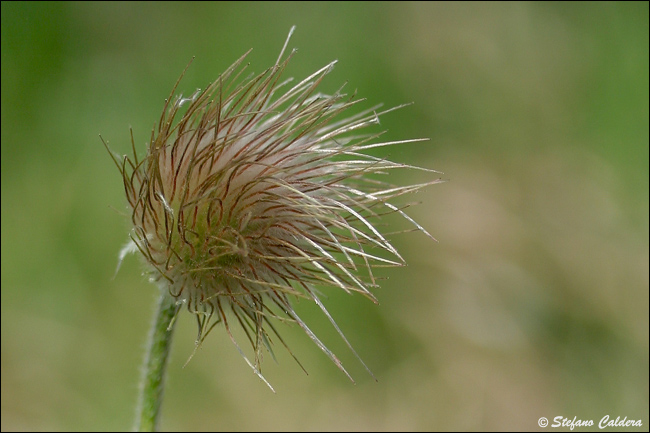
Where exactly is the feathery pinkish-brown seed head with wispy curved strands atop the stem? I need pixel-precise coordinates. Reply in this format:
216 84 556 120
107 29 439 386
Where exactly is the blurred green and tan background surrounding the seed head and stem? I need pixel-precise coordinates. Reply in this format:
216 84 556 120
1 2 650 431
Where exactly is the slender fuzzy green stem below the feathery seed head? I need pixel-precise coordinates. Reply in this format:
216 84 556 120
135 288 178 432
